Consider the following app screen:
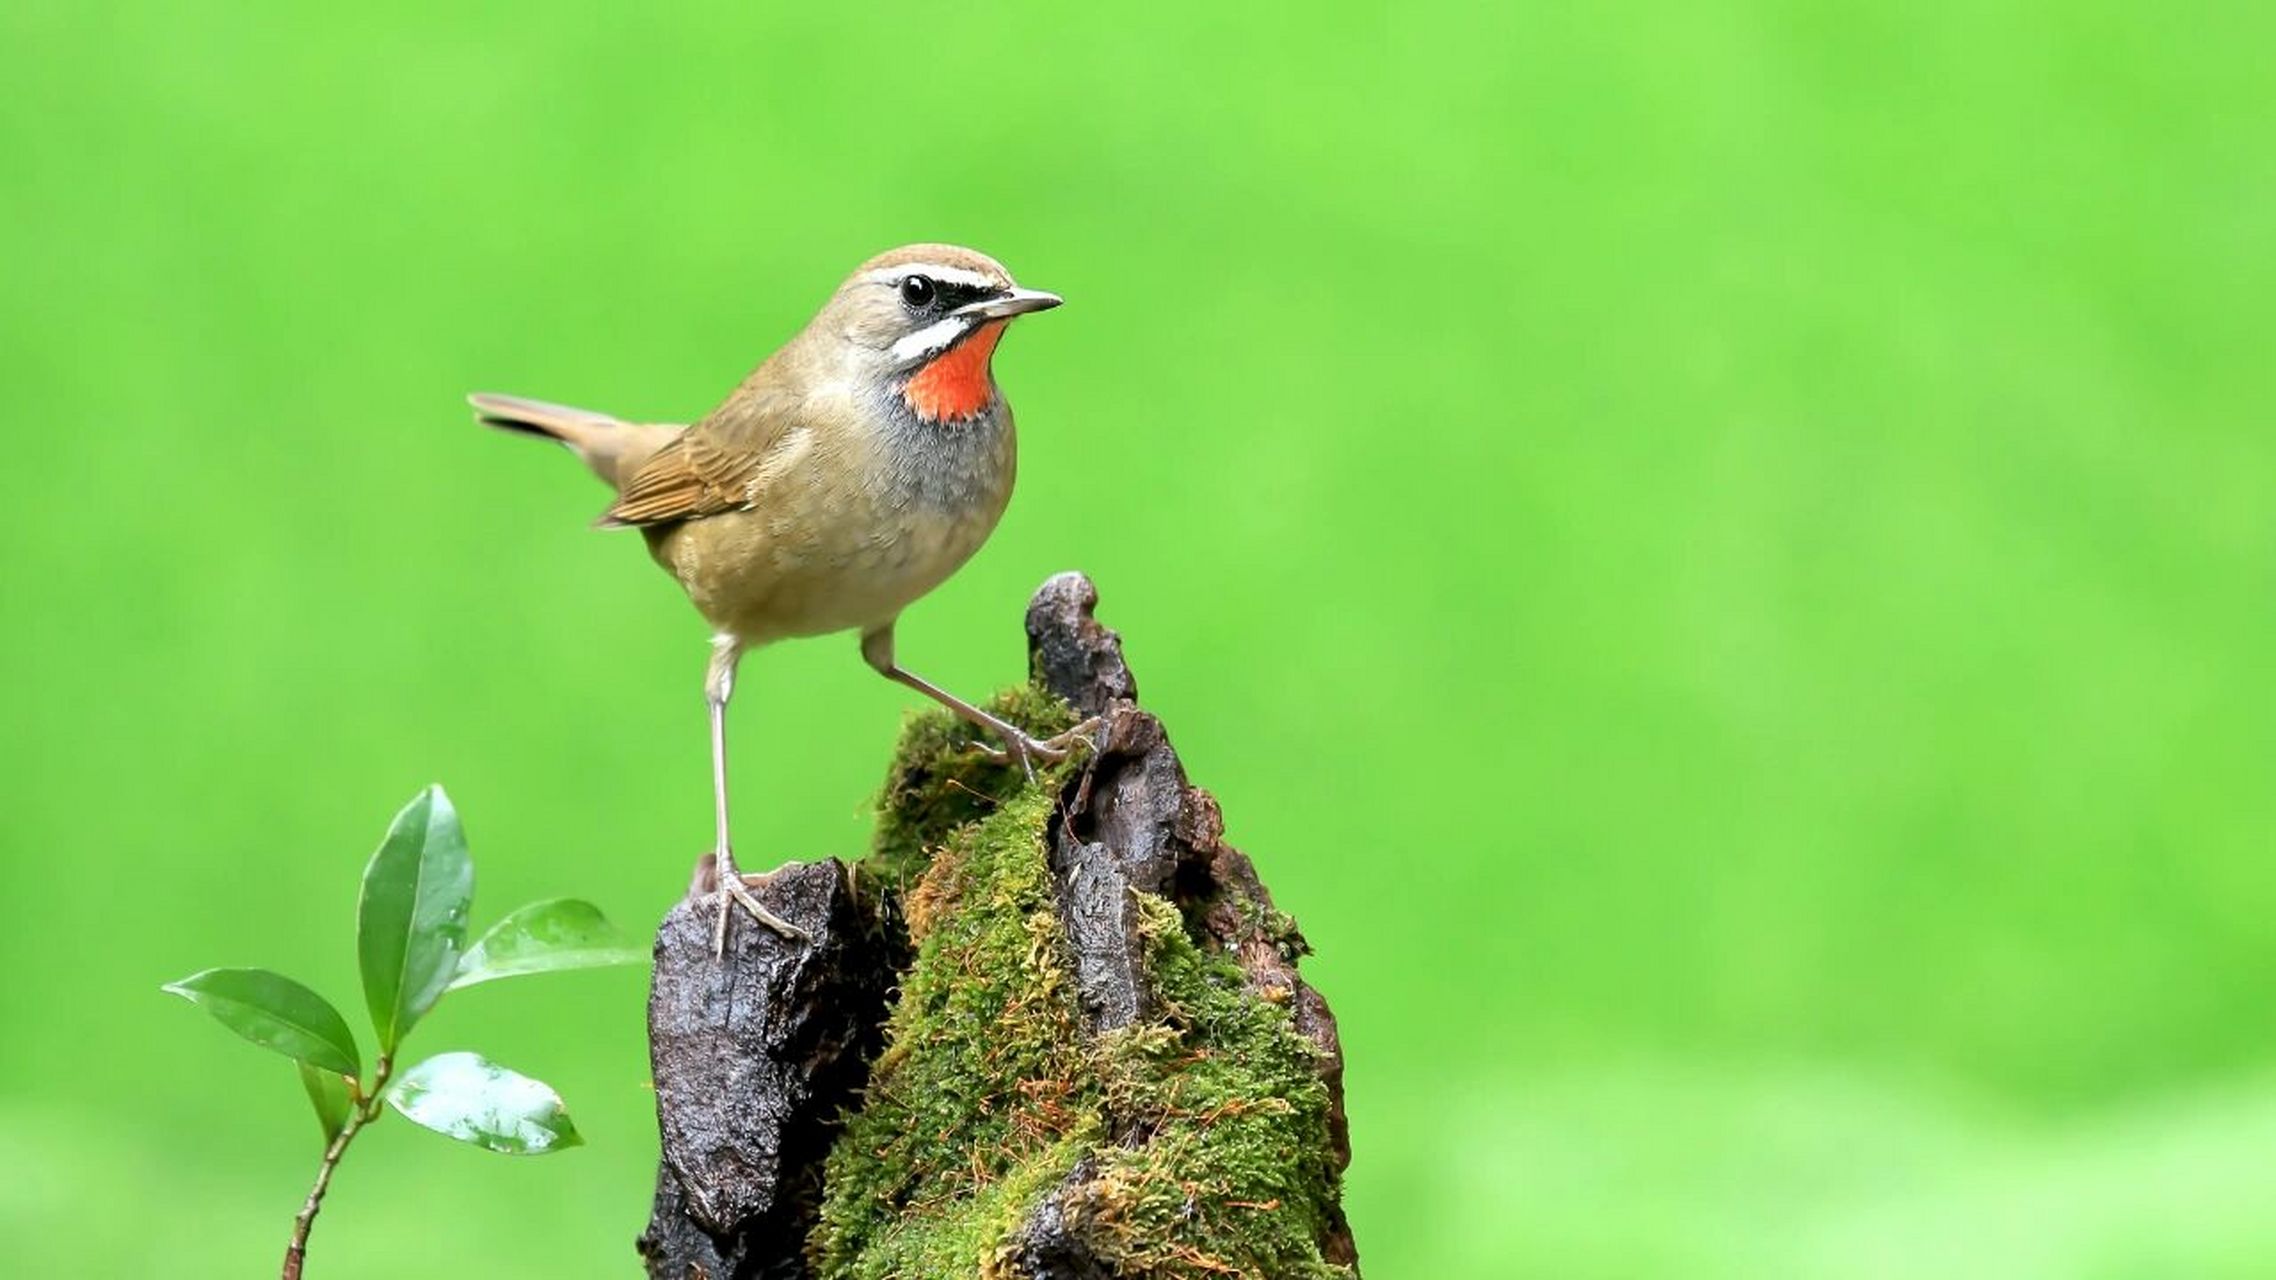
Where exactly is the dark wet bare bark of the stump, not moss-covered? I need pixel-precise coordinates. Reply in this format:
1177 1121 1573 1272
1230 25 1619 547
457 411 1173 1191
640 574 1356 1280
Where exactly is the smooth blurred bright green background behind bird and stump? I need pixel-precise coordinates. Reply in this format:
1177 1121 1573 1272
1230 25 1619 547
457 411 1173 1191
0 0 2276 1280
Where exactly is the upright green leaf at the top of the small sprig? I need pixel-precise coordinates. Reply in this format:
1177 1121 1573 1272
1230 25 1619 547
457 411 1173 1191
355 786 473 1055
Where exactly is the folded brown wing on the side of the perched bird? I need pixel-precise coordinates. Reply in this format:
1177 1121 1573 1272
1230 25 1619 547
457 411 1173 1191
601 385 794 528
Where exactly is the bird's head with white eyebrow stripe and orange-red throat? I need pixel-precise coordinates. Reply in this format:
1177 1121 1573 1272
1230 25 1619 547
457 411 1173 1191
817 244 1058 421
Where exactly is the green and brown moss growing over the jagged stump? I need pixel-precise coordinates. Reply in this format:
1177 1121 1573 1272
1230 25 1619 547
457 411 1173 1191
810 690 1345 1280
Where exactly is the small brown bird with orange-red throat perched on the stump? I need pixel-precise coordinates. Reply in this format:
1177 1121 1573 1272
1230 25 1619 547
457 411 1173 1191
469 244 1083 950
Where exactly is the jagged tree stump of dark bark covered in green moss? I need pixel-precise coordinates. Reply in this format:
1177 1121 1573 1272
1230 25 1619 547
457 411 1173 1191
640 574 1359 1280
